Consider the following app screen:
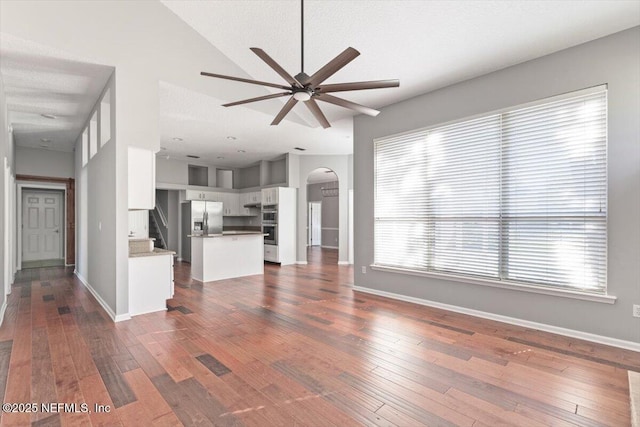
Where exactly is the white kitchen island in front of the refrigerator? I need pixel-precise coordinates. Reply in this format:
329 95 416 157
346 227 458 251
189 231 264 282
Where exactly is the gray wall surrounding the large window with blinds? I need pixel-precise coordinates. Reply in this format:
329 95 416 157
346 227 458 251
354 27 640 343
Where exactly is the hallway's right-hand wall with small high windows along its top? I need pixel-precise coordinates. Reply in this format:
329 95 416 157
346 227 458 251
75 74 128 318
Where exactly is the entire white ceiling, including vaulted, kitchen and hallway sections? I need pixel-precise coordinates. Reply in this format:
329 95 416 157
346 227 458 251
0 0 640 167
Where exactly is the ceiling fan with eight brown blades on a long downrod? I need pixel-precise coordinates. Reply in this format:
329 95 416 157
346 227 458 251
200 0 400 129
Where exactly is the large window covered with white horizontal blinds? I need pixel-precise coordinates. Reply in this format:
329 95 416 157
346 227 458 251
374 87 607 293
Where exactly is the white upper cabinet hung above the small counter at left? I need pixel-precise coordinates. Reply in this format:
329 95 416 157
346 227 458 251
128 147 156 210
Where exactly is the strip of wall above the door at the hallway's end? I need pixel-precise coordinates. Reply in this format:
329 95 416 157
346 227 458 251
15 146 75 178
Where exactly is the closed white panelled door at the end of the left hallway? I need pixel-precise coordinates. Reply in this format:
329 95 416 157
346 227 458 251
22 191 64 261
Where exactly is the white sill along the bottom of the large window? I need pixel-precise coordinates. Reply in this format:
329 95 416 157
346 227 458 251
369 264 617 304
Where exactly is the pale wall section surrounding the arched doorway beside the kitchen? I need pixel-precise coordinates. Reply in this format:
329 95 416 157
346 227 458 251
297 155 349 264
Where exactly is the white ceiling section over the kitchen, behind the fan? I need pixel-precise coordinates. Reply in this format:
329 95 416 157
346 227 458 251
158 82 353 167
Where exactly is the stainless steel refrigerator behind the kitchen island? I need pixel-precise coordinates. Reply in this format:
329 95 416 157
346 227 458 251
182 201 222 262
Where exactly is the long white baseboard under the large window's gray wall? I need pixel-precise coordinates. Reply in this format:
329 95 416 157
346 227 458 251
353 286 640 351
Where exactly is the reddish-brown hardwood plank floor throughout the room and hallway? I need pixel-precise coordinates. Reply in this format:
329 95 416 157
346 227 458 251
0 253 640 427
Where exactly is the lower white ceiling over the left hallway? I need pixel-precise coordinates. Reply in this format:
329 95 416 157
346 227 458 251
0 33 113 151
